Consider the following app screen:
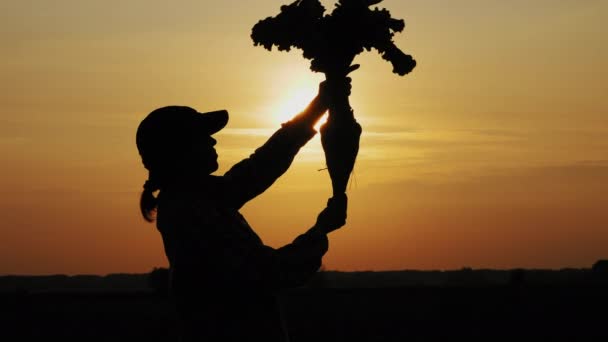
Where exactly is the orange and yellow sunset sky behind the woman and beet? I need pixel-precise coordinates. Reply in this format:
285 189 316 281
0 0 608 274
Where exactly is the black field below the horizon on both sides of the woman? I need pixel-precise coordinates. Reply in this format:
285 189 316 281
0 261 608 342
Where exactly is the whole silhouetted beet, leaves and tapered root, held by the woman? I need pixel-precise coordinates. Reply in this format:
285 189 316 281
251 0 416 195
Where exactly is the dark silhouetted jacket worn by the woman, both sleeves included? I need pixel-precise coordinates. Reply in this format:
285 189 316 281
157 122 328 341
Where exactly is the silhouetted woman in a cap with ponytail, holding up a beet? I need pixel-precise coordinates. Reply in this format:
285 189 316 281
136 77 350 341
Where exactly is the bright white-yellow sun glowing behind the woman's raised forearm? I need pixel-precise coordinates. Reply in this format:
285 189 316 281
271 86 327 131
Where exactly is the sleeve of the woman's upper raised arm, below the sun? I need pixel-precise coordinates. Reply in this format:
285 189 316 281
224 120 317 209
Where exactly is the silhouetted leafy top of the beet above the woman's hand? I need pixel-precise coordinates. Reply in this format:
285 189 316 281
251 0 416 76
